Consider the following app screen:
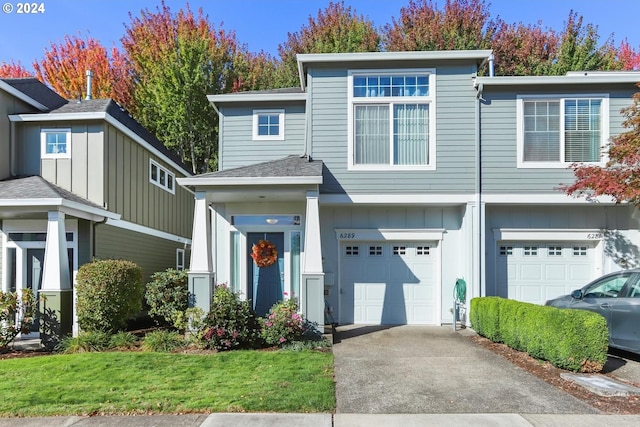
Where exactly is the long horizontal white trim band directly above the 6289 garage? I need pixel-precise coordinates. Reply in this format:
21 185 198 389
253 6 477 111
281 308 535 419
320 194 475 205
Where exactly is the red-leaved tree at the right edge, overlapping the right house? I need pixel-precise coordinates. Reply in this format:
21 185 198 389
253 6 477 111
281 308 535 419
562 86 640 206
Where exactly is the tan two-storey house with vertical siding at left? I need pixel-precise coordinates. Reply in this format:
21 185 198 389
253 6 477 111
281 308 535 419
0 78 193 333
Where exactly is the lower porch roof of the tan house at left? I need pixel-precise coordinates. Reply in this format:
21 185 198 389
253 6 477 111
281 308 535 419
0 175 120 218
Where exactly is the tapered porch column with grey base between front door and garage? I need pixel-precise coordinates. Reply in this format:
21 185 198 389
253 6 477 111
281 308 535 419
300 191 324 331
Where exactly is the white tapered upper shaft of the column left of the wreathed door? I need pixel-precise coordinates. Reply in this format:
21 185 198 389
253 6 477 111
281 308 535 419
189 191 212 273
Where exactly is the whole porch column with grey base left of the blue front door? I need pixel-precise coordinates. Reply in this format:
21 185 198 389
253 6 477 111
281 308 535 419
189 191 213 312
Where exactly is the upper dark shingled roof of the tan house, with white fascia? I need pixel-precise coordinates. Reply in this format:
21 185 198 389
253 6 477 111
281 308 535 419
9 98 191 176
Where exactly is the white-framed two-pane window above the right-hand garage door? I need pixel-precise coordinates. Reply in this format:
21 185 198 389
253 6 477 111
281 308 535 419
516 94 609 168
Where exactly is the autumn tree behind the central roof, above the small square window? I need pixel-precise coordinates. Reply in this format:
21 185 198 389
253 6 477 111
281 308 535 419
277 2 380 87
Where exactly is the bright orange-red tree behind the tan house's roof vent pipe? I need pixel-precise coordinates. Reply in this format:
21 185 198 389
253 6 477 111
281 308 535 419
33 36 129 103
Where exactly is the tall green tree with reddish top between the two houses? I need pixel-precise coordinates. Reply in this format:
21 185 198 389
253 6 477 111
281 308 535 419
121 2 243 173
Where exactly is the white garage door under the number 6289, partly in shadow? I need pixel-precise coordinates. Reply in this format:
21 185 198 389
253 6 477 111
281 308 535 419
340 242 437 325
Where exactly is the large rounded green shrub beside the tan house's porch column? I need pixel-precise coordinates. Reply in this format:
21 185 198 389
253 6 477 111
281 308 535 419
76 260 144 332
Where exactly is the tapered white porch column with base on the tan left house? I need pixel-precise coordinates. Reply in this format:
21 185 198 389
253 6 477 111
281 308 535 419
40 211 73 340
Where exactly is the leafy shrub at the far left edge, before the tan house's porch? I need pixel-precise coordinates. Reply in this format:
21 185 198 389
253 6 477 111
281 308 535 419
0 289 36 350
